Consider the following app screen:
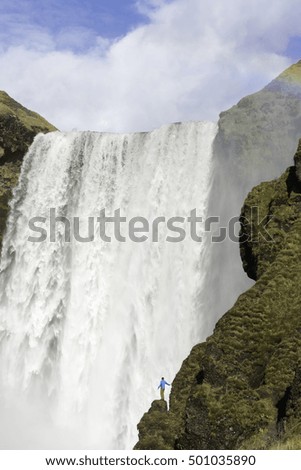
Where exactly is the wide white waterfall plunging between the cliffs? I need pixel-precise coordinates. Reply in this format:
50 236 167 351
0 122 216 449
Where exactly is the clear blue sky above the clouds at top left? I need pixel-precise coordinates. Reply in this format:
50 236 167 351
0 0 147 43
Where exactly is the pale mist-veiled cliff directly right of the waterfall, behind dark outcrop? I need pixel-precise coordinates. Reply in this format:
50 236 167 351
200 61 301 336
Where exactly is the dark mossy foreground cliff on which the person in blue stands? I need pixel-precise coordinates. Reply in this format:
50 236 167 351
136 141 301 449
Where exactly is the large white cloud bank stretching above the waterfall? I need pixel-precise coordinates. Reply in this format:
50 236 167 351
0 0 301 131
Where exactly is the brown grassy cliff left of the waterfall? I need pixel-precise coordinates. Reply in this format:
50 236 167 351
0 91 56 248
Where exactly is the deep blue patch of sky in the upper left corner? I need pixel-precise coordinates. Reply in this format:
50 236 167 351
0 0 151 52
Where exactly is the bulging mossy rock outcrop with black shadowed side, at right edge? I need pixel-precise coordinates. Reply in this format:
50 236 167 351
240 154 301 280
